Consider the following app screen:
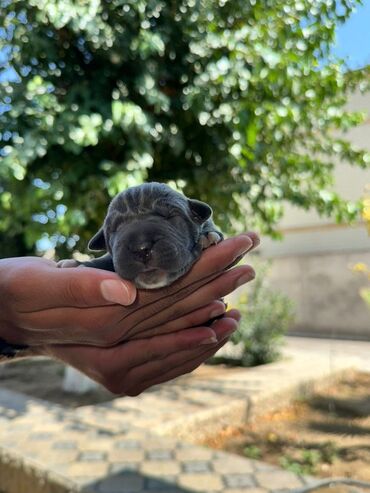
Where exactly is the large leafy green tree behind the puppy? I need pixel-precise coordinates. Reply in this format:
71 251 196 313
0 0 370 255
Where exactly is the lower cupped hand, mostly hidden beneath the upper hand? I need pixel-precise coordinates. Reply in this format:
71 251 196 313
43 308 240 396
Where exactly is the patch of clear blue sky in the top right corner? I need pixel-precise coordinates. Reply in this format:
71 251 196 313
333 0 370 69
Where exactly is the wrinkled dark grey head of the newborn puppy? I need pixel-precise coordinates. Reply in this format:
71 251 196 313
89 183 212 289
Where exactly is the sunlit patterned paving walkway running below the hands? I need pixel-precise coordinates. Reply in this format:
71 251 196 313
0 338 370 493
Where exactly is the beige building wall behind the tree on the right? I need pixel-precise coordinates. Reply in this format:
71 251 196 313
260 88 370 339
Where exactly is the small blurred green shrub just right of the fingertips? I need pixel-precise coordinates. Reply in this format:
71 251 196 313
231 263 294 366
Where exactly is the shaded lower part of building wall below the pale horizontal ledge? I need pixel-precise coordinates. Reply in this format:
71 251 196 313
264 250 370 340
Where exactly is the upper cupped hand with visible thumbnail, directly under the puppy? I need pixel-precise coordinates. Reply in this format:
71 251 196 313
0 233 258 347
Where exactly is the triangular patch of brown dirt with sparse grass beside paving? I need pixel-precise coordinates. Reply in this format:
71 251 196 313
205 371 370 480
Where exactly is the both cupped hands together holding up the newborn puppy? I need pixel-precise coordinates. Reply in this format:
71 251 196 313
0 233 259 396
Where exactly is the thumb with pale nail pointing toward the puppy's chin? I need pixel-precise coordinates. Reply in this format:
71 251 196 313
17 263 136 313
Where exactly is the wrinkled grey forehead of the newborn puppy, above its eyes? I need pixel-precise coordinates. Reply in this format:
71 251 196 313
108 183 187 219
